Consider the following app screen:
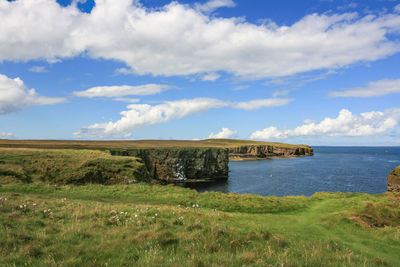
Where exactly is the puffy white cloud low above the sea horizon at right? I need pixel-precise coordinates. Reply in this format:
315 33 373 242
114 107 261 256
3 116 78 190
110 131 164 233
250 108 400 140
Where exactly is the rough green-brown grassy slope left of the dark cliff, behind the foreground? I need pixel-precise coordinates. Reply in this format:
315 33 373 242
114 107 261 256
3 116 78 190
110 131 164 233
0 148 149 184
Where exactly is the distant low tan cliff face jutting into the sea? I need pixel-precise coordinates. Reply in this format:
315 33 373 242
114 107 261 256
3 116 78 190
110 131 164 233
229 145 314 160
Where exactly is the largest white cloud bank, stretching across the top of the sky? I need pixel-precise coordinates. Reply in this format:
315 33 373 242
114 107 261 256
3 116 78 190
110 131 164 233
0 0 400 78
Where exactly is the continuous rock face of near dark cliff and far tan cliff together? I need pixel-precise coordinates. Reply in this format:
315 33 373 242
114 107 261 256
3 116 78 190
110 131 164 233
111 145 314 182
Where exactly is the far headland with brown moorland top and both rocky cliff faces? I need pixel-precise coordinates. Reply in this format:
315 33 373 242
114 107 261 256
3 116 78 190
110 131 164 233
0 139 314 182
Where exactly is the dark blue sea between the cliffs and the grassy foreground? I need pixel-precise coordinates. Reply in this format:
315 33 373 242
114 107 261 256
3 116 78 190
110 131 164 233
190 147 400 196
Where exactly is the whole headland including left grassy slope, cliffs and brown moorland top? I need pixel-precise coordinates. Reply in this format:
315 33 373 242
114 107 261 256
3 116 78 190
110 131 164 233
0 139 313 184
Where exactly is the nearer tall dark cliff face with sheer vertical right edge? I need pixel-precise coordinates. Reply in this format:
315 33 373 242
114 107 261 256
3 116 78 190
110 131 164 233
111 148 229 182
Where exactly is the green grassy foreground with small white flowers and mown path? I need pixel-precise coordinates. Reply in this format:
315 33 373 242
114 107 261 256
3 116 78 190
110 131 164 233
0 184 400 266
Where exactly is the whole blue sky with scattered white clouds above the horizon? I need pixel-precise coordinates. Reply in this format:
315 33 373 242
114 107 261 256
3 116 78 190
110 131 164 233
0 0 400 146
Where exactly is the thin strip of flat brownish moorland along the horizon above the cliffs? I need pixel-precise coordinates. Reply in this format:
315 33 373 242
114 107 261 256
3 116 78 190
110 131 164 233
0 139 309 149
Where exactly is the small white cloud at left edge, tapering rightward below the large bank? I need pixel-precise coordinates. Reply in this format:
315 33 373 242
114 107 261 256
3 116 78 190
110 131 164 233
0 74 66 114
